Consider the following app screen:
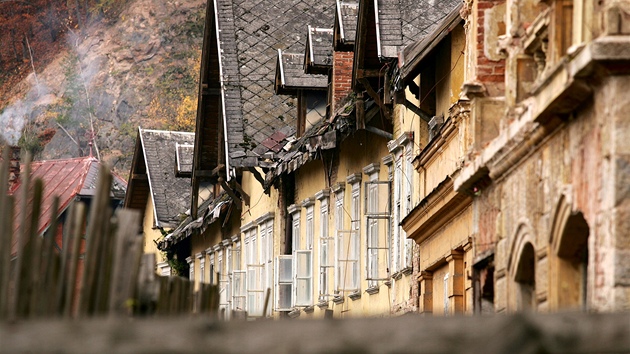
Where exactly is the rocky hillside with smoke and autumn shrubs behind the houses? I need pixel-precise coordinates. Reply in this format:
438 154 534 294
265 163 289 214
0 0 205 175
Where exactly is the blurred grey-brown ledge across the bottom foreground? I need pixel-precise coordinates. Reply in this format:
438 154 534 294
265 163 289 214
0 313 630 353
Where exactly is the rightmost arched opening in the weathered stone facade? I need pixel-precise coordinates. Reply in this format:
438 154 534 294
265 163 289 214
549 196 589 310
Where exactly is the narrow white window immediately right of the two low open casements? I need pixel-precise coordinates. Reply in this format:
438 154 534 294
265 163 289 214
318 191 335 301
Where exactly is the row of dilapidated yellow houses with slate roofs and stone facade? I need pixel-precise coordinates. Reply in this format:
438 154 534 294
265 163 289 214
125 0 630 318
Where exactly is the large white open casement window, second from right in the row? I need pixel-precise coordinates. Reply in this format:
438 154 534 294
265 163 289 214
364 164 390 287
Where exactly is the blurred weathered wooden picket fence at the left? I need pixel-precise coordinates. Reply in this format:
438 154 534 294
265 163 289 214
0 148 218 320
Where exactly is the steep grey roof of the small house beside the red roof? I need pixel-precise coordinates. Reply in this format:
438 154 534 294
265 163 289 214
138 128 195 227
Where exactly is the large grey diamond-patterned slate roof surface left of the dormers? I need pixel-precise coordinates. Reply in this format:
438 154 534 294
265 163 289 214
214 0 334 167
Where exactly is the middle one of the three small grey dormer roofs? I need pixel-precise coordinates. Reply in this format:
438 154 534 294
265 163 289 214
304 26 333 75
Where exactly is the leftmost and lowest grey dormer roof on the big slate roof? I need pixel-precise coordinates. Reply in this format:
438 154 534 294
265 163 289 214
276 49 328 95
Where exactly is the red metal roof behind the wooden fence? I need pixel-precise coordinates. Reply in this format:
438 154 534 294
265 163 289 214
9 156 127 253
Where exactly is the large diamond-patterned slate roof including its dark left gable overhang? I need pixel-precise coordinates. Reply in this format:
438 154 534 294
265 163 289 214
198 0 334 173
